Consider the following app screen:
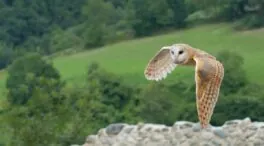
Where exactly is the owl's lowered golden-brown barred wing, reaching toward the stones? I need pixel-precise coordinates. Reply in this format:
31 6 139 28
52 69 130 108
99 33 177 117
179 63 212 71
193 54 224 128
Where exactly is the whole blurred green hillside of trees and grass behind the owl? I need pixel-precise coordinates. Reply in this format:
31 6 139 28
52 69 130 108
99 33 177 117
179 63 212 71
0 0 264 146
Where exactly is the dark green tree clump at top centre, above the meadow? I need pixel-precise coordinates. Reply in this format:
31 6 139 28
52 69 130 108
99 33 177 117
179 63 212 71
128 0 187 36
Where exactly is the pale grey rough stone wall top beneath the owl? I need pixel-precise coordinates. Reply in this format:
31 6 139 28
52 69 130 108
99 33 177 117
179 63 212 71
72 118 264 146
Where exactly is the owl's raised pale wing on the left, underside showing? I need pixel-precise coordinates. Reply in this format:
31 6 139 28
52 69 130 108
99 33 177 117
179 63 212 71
144 47 176 81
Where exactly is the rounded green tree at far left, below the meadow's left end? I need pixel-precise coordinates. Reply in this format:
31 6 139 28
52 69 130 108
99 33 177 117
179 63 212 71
6 53 62 104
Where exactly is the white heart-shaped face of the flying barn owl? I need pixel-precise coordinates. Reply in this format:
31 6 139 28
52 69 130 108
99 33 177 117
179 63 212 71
170 45 189 64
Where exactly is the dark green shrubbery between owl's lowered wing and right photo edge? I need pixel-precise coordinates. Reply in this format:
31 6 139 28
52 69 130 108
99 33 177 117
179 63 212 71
212 94 264 125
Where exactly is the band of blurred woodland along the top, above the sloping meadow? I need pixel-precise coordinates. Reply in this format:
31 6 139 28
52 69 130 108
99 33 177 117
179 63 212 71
0 0 264 68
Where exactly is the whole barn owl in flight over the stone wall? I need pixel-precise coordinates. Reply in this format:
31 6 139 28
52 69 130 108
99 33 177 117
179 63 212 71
144 44 224 128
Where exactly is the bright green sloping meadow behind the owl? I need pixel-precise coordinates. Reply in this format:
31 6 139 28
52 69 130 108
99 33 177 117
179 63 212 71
0 24 264 102
